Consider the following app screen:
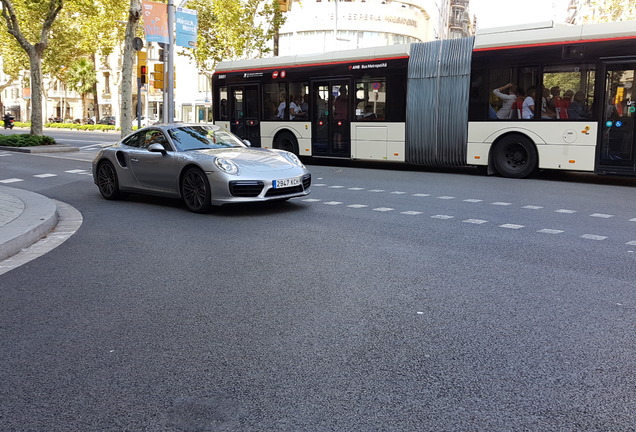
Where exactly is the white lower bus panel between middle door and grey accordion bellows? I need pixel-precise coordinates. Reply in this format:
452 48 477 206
351 122 406 162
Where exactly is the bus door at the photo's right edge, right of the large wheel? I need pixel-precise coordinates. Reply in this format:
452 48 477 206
597 60 636 174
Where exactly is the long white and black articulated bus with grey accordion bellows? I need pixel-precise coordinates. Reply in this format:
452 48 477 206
213 22 636 178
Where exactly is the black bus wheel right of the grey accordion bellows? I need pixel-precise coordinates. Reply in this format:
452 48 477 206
493 135 538 178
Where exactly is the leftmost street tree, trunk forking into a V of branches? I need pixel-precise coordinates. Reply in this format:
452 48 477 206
0 0 63 135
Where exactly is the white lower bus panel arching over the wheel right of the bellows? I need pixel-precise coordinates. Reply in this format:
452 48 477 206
467 121 598 171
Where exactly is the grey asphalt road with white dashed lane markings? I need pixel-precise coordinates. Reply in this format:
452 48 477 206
0 143 636 432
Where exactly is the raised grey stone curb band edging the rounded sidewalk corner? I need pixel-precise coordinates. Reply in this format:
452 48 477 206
0 186 58 261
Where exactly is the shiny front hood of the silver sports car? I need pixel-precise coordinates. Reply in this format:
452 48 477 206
191 148 296 171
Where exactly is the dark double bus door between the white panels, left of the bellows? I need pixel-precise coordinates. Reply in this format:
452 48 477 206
311 79 352 158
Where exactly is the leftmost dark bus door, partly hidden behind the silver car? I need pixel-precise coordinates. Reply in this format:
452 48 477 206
229 84 261 147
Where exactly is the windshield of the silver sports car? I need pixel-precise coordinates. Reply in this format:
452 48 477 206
168 126 247 151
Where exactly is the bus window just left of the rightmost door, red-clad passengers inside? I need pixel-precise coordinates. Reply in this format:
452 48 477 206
543 64 595 120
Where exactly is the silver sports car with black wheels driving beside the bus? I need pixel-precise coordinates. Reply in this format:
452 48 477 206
93 124 311 213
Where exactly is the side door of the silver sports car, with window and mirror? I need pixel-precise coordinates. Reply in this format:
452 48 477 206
129 129 179 194
